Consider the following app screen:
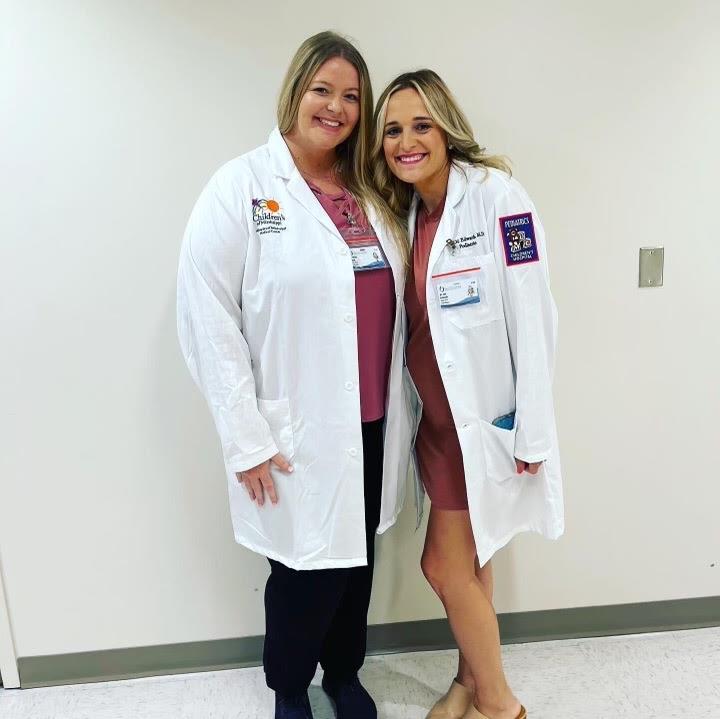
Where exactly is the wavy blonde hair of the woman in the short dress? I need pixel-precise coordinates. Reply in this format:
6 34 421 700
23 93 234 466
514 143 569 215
372 70 511 224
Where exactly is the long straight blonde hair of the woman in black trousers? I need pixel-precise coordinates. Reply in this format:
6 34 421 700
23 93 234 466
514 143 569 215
277 30 407 260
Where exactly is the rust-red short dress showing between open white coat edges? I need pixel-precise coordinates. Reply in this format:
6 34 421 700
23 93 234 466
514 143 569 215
405 200 468 510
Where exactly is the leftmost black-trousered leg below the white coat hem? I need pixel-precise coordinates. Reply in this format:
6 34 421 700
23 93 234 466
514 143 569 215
263 560 349 696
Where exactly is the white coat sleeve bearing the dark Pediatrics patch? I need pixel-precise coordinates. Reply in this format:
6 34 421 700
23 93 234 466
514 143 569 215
488 180 557 462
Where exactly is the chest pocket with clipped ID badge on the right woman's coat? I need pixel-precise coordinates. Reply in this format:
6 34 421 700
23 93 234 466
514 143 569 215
432 254 502 330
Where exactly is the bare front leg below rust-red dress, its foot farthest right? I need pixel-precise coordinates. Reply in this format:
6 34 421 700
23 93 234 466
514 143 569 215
422 507 520 719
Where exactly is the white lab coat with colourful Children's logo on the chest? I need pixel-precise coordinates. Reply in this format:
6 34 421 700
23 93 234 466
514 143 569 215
177 129 411 569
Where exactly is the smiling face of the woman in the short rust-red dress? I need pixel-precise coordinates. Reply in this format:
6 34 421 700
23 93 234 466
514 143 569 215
383 88 449 187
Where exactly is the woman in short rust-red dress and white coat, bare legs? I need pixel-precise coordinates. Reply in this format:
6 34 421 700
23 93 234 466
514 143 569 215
373 70 563 719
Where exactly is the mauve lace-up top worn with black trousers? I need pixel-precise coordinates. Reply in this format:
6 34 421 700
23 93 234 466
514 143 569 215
308 182 395 422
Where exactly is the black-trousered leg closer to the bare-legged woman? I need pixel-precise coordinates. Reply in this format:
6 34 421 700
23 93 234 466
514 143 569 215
320 420 383 681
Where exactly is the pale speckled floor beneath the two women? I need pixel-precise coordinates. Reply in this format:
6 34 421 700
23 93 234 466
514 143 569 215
0 628 720 719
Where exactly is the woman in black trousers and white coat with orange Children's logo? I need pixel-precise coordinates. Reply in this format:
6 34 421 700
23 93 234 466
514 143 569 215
178 32 410 719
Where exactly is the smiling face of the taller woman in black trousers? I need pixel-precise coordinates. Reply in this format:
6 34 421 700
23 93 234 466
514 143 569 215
288 57 360 151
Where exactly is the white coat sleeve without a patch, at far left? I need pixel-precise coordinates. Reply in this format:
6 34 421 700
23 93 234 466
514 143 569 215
177 169 278 472
